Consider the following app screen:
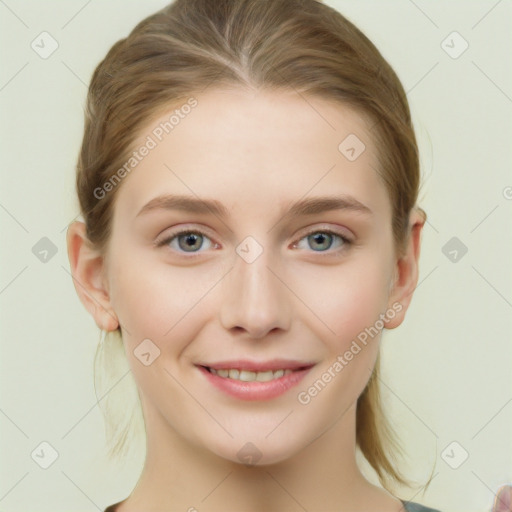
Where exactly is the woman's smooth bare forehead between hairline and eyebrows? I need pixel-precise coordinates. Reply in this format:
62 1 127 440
114 89 389 222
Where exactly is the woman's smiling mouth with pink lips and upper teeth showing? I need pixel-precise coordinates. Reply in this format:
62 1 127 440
196 361 314 400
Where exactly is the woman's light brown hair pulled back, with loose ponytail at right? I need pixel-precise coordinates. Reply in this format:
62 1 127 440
77 0 426 487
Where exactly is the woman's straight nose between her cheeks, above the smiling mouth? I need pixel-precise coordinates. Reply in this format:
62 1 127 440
220 244 292 339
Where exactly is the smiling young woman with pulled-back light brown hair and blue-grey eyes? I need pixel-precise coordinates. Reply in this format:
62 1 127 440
68 0 456 512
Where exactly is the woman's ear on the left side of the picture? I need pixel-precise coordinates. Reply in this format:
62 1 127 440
66 221 119 331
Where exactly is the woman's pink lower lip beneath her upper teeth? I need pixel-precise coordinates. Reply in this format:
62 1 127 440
198 366 312 400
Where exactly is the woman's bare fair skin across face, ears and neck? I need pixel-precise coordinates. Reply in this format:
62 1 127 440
68 89 424 512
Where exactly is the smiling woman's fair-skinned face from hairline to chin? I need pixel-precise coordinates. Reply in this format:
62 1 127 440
100 89 405 464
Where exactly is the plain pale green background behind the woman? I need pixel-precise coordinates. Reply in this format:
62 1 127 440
0 0 512 512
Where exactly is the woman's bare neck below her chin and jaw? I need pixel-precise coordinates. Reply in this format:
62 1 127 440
118 404 400 512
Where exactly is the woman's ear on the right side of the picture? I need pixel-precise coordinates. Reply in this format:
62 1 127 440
385 209 426 329
